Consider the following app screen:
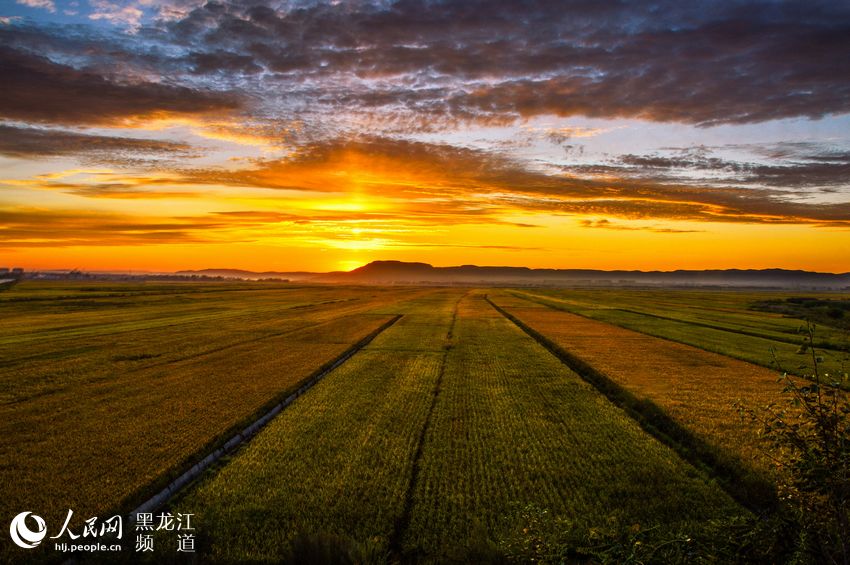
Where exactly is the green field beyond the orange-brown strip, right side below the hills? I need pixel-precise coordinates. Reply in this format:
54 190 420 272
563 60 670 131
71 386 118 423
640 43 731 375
516 289 850 387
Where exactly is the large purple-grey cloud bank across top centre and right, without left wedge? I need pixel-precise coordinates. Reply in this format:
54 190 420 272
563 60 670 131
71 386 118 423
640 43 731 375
154 0 850 125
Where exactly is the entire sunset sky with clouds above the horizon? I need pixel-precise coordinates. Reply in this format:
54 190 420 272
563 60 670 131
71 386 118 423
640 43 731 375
0 0 850 272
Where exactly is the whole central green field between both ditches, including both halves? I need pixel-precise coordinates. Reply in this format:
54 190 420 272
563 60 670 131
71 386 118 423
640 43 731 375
175 290 745 562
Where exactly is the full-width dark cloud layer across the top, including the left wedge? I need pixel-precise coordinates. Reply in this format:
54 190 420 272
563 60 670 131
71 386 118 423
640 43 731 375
0 0 850 129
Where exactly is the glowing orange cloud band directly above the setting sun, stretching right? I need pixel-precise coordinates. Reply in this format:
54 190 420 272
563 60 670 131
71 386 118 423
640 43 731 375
176 138 850 227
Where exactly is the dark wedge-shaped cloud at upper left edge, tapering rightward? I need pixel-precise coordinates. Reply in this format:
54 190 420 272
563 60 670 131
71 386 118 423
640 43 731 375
0 45 239 125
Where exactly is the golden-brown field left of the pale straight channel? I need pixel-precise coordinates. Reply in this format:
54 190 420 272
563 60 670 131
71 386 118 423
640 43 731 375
0 284 416 519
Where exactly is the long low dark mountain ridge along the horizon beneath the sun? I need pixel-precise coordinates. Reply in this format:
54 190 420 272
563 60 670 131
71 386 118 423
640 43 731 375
177 261 850 290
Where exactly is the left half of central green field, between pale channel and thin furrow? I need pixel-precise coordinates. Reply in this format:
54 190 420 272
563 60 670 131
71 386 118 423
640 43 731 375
177 290 462 562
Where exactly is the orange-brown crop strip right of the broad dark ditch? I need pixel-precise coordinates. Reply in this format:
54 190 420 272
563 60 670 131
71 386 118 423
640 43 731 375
491 294 782 505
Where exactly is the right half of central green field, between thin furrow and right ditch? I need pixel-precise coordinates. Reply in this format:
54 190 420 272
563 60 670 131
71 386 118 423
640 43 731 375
403 295 743 561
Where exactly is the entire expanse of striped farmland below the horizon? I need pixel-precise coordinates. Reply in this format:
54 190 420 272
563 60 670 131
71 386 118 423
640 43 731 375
0 281 846 563
